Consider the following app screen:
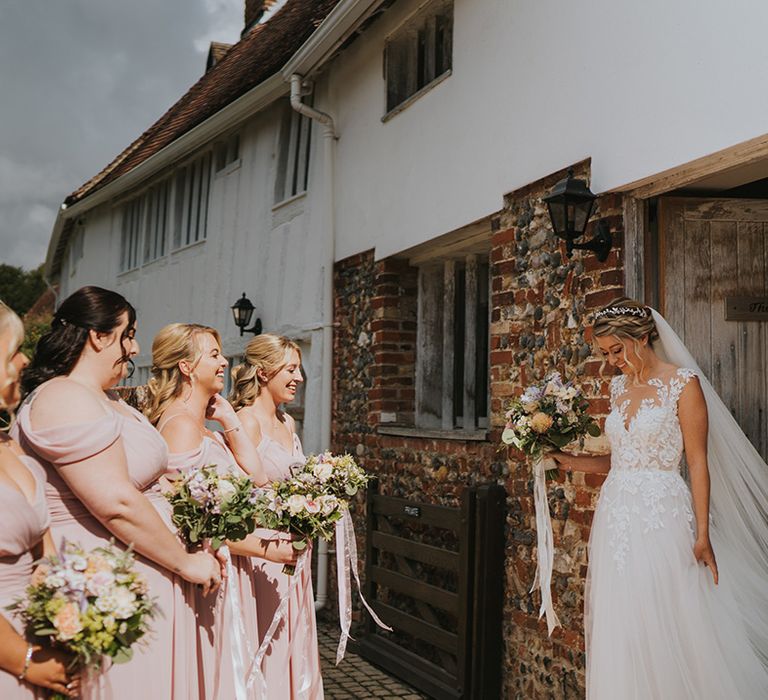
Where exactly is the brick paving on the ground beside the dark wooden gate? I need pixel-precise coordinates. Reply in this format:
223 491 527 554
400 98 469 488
317 623 428 700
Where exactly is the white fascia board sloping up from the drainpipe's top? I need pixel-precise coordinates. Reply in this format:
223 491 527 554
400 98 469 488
282 0 384 81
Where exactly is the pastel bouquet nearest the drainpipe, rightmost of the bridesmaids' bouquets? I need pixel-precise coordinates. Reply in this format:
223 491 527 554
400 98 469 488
257 452 369 575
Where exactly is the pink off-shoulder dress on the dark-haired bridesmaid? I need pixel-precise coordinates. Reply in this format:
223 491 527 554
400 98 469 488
13 385 200 700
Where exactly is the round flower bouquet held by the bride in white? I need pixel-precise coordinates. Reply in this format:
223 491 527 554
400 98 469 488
501 372 600 477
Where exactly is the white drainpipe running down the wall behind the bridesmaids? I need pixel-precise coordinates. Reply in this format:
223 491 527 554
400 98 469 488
291 73 337 610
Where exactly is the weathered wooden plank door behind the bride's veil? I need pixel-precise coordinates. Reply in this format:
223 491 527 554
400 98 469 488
659 198 768 459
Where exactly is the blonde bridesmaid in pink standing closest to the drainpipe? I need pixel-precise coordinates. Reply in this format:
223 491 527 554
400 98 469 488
230 334 323 700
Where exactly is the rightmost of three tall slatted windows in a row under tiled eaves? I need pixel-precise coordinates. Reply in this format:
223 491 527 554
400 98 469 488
173 152 211 249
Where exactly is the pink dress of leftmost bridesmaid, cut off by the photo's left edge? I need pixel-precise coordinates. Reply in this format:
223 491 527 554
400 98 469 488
0 457 50 700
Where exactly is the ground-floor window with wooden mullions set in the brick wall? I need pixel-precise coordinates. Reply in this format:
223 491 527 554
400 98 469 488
415 253 490 431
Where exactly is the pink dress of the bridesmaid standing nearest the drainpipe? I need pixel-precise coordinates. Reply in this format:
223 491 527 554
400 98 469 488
253 433 323 700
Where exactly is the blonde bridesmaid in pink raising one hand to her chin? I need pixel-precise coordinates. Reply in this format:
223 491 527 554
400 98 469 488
146 323 295 700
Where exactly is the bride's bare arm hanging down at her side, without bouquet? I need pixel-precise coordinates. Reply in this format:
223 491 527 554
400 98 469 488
677 377 718 583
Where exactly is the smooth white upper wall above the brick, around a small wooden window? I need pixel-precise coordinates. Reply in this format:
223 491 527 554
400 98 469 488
328 0 768 259
